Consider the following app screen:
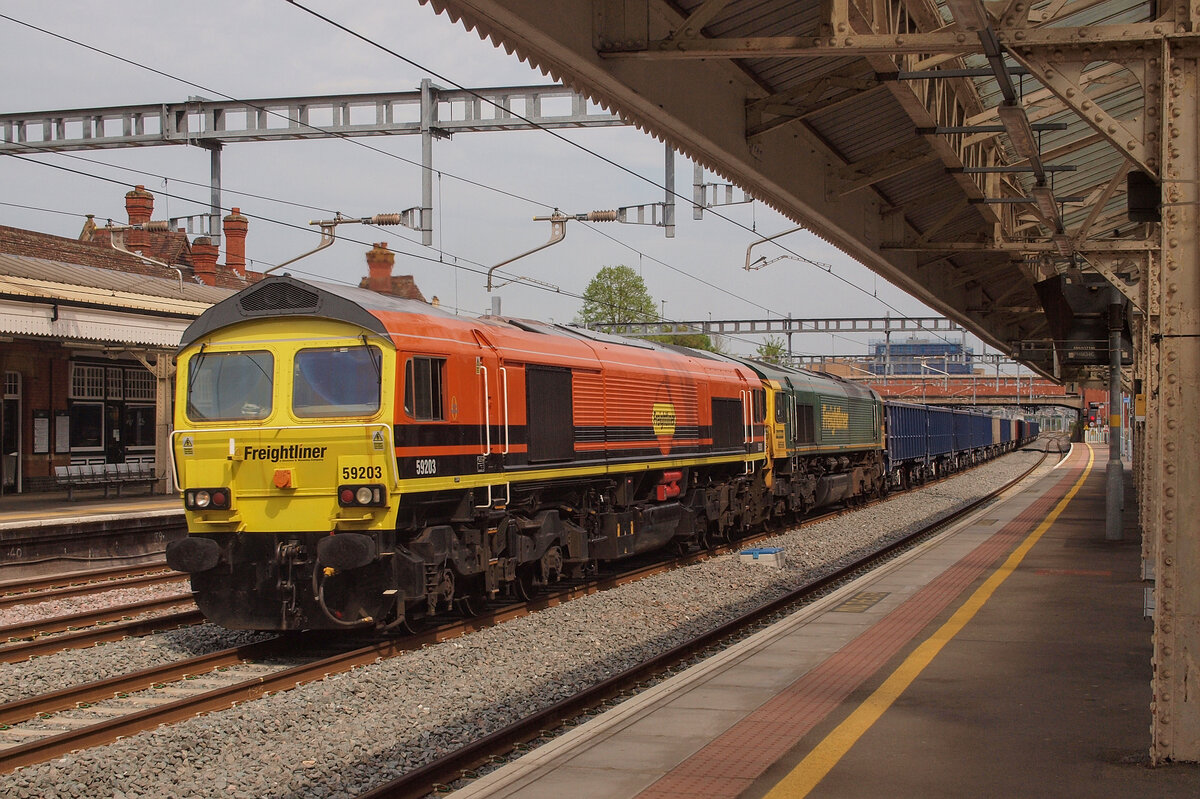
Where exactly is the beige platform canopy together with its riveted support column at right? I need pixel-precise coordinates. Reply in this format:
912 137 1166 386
421 0 1200 761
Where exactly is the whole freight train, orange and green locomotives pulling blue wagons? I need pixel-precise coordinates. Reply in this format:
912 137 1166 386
167 277 1037 630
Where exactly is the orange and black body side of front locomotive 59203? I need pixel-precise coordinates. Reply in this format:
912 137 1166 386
377 312 764 477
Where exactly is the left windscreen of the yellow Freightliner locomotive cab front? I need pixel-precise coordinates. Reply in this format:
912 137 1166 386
187 349 275 421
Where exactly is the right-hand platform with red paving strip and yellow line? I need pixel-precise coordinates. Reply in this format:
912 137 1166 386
451 444 1200 799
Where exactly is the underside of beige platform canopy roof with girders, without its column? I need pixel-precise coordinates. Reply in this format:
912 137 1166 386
422 0 1161 380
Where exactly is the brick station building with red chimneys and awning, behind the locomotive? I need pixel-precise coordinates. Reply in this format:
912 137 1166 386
0 186 424 495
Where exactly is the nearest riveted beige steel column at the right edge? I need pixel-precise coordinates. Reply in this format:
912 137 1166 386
1147 40 1200 763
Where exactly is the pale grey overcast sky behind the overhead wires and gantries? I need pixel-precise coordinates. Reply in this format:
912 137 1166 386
0 0 1012 364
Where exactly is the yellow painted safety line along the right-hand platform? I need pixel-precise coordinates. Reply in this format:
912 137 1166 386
766 446 1096 799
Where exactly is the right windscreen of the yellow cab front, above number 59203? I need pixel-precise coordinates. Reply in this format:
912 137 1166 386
292 347 383 416
